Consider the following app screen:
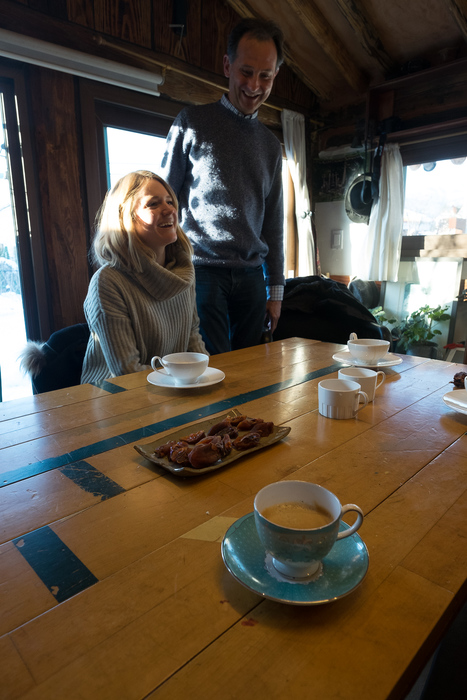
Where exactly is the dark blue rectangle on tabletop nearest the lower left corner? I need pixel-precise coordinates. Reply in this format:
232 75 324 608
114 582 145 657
13 525 99 603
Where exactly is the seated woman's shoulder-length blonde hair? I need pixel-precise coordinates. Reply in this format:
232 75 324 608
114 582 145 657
92 170 193 272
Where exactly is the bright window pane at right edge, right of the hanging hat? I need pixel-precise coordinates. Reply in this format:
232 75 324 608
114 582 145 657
404 157 467 236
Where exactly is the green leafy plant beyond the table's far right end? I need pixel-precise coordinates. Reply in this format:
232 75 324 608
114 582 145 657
392 304 451 357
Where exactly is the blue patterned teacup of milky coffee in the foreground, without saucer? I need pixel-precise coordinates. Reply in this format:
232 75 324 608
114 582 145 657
254 481 363 578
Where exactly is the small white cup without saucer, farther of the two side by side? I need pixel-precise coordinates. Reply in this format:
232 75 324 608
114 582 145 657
318 379 368 419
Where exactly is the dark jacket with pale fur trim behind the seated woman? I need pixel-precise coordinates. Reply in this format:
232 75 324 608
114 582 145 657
20 323 89 394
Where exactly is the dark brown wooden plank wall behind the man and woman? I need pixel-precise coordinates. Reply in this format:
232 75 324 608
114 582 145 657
0 0 316 339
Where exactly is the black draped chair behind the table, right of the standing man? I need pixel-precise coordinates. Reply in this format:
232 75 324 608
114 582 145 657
274 275 391 345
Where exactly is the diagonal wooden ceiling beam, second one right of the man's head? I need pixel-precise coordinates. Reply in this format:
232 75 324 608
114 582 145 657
286 0 368 93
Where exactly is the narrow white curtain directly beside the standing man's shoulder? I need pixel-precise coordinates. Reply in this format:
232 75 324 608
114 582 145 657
282 109 316 277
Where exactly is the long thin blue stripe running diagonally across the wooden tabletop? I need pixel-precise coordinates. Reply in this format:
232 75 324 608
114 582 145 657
0 363 342 487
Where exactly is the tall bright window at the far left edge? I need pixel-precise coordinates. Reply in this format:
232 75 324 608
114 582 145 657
0 72 45 401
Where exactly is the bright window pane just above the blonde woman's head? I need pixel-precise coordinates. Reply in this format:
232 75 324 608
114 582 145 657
105 127 165 187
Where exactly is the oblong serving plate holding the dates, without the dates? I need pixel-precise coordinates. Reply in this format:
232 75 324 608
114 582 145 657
134 408 290 476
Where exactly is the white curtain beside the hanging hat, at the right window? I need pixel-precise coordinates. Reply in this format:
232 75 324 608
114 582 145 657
358 144 404 282
